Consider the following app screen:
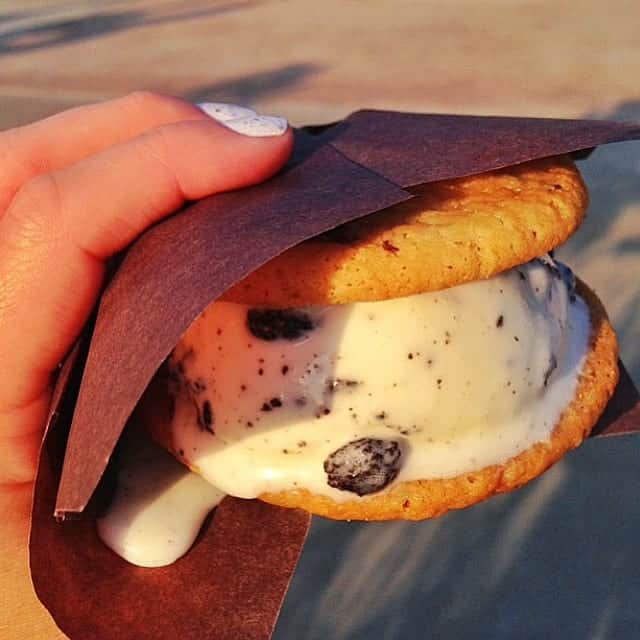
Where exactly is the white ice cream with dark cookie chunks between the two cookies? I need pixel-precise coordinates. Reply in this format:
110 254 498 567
161 256 590 501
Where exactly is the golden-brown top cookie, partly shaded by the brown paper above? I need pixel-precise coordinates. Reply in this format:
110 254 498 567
223 156 588 308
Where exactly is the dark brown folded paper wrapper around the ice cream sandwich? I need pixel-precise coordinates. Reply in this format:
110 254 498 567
30 111 640 640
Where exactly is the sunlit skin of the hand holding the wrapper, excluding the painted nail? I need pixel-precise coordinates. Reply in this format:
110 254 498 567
0 93 292 640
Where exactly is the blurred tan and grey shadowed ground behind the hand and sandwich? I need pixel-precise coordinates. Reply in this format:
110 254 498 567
0 0 640 640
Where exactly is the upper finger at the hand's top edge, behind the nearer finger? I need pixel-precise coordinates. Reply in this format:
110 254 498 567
0 91 205 210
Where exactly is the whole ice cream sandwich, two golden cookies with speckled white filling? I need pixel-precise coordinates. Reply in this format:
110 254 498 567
140 157 618 520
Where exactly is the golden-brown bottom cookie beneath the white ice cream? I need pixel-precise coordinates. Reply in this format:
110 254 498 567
260 282 618 520
